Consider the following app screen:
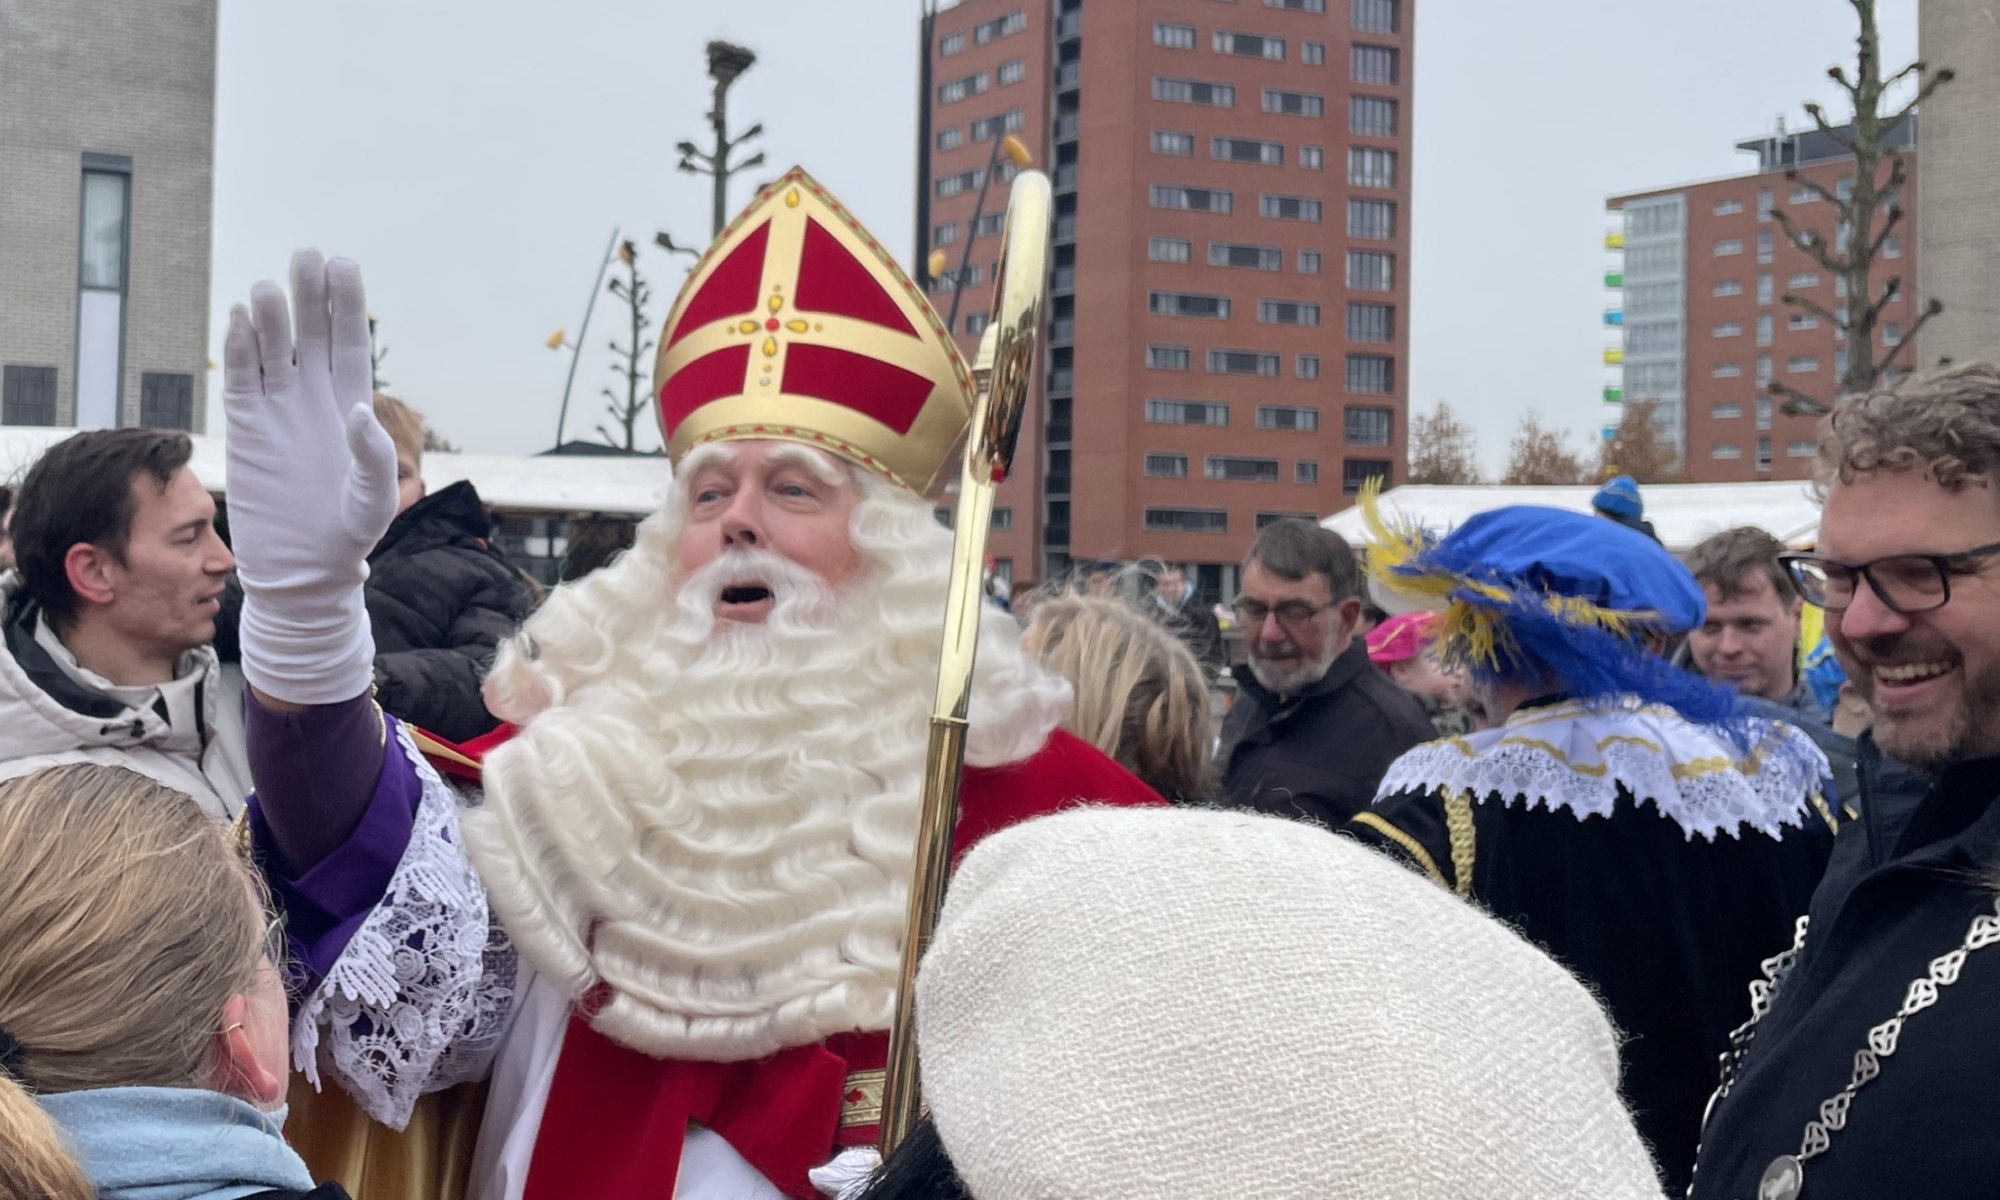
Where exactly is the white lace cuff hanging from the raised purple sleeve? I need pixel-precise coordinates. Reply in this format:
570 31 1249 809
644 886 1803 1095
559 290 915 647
292 722 516 1130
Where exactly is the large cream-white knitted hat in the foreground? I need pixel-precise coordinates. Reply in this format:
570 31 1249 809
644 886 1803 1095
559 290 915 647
916 808 1660 1200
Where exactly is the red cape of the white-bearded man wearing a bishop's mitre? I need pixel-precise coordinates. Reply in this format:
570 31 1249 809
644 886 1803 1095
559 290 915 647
418 726 1164 1200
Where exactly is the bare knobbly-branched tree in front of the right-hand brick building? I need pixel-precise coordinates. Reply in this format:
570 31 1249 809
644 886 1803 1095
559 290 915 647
1770 0 1954 416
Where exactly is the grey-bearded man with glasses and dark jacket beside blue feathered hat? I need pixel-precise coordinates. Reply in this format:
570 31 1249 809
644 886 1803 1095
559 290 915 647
1220 518 1436 828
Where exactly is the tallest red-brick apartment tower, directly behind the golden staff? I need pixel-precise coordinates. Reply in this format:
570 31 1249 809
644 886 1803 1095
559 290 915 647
914 0 1416 600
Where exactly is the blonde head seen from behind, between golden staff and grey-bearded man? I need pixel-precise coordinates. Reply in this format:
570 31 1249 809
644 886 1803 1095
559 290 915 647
1022 596 1214 804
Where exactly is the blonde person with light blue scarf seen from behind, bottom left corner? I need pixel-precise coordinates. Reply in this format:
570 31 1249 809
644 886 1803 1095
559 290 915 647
0 764 346 1200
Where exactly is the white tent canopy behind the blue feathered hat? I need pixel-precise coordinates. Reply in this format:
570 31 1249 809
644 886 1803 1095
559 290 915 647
1320 482 1820 552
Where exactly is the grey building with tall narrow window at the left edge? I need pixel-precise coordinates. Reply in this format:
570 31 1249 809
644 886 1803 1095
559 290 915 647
0 0 216 430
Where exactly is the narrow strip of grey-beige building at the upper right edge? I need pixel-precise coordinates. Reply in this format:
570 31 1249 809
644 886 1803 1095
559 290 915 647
1916 0 2000 366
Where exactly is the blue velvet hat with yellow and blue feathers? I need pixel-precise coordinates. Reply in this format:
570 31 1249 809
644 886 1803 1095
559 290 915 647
1362 494 1740 724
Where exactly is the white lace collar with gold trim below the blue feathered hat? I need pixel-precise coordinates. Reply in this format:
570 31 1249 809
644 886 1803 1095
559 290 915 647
1376 700 1832 840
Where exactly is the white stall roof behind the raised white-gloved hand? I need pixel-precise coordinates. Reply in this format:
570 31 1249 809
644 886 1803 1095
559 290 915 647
0 426 674 516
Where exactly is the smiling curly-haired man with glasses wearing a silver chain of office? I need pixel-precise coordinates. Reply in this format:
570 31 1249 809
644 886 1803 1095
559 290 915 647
1692 364 2000 1200
